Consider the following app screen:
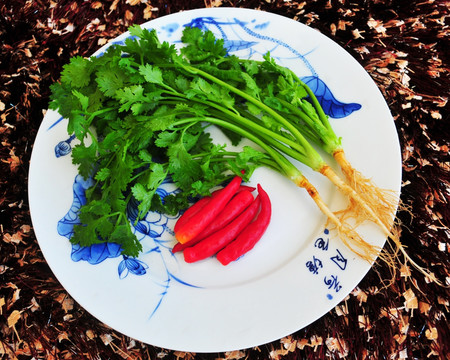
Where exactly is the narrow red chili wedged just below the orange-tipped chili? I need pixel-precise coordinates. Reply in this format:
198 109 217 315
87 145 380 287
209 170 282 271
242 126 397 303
172 191 253 253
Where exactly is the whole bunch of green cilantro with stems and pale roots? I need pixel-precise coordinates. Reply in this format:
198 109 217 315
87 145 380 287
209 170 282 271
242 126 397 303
50 26 412 282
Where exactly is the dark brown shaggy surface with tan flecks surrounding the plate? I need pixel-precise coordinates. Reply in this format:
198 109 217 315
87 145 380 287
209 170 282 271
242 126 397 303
0 0 450 360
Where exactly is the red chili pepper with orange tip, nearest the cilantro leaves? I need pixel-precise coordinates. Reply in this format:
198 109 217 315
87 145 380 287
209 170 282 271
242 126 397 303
175 176 242 244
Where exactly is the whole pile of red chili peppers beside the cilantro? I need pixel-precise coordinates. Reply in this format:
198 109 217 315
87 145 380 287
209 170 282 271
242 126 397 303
172 176 272 265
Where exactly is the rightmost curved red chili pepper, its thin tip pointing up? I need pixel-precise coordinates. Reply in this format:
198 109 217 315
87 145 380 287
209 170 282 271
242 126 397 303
217 184 272 265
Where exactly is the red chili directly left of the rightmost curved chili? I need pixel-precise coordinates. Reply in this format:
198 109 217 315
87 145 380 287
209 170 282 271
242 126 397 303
184 196 260 263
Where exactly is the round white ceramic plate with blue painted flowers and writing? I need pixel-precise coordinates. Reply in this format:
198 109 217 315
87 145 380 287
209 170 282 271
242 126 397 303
29 8 401 352
